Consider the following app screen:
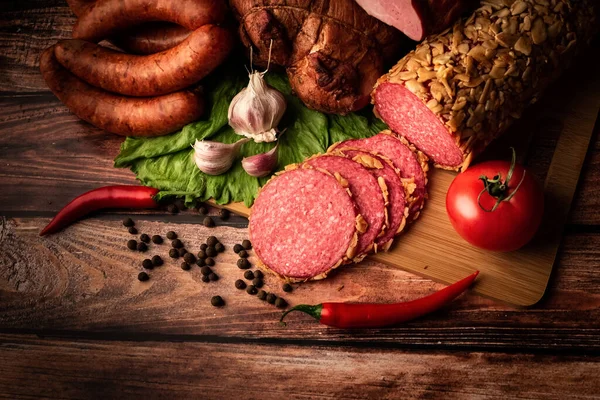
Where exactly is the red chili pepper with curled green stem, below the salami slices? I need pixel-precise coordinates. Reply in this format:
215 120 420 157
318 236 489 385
280 271 479 328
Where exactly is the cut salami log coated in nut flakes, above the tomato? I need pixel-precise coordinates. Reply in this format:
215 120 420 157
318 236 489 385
372 0 597 170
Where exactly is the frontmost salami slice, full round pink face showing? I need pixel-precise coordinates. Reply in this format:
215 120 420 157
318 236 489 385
249 168 365 281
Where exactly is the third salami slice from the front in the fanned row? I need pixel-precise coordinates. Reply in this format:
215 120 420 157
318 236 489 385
334 147 408 252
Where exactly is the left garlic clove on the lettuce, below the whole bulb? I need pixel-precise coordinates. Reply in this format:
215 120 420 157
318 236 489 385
192 139 250 175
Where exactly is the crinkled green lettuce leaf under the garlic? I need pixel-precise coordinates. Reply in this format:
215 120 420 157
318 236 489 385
115 66 387 206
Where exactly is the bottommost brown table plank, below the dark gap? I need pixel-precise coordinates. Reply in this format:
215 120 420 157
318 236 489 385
0 335 600 400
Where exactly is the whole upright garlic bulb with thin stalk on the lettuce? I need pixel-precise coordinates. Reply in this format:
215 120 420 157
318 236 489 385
227 71 287 143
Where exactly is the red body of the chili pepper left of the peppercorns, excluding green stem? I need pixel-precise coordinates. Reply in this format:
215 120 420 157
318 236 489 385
40 185 158 236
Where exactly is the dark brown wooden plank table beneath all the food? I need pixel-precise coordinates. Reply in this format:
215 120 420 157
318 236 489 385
0 0 600 399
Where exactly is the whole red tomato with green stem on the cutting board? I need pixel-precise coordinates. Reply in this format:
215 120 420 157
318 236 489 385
446 155 544 251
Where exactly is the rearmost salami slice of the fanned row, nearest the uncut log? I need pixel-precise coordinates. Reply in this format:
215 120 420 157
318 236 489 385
330 131 429 222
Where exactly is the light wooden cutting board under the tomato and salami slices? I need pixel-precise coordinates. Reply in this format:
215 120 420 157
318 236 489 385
213 61 600 306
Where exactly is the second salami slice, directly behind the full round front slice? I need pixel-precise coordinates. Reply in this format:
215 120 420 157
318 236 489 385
305 154 387 261
